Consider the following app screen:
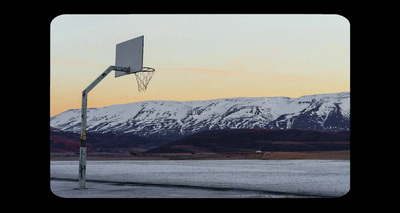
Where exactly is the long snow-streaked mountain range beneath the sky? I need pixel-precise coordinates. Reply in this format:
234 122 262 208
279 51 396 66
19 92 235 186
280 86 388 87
50 92 350 138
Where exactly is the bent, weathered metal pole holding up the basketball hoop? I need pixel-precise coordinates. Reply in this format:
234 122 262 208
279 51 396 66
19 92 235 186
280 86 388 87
78 66 129 189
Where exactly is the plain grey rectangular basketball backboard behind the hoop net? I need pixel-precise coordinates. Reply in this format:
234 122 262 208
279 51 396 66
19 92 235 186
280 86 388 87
115 36 144 77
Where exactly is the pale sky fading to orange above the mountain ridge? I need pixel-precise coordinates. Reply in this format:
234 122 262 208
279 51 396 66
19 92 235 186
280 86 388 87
50 14 350 116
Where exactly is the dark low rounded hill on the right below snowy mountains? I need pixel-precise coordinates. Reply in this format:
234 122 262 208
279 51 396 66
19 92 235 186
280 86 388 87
147 129 350 153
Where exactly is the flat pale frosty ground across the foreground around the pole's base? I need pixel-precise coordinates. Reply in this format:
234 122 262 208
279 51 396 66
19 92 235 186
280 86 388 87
50 160 350 198
